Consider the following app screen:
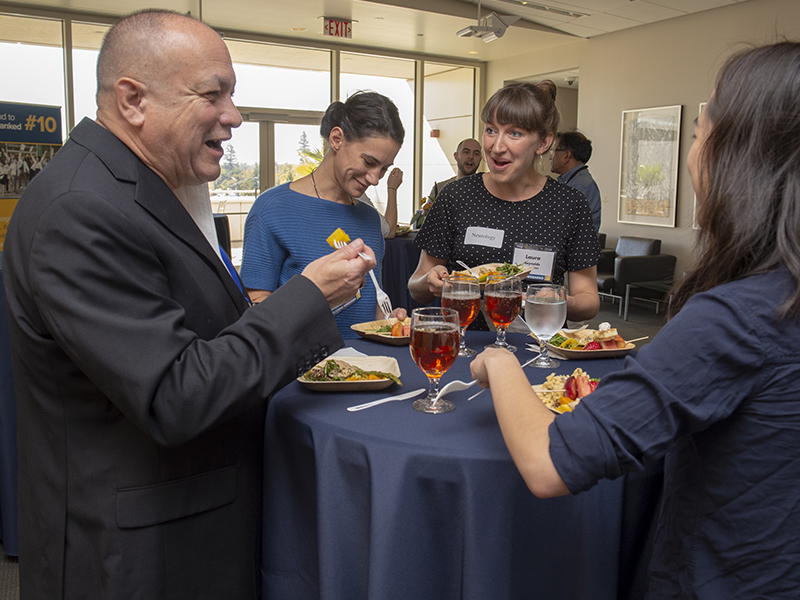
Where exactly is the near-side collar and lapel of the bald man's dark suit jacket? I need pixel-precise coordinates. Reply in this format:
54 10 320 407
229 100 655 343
70 119 247 313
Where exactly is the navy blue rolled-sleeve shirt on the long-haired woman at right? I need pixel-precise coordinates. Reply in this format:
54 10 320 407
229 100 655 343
549 269 800 600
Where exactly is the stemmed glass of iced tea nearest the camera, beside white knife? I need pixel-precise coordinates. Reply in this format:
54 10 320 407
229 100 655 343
409 307 459 414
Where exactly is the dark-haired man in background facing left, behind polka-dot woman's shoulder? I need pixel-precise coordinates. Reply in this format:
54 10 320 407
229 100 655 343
550 131 602 233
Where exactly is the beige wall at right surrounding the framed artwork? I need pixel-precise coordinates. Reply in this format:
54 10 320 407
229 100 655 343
487 0 800 273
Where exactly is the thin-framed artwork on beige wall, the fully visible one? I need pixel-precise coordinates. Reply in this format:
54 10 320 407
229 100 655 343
617 105 682 227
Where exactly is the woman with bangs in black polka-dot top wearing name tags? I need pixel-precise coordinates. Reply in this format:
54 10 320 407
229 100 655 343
408 81 601 327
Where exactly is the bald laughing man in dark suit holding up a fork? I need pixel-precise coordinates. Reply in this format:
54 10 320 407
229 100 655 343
3 10 374 600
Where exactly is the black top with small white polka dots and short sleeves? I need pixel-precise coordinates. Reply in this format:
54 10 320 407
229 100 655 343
415 173 602 284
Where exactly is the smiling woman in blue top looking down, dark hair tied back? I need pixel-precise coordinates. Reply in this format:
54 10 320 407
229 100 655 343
241 92 406 338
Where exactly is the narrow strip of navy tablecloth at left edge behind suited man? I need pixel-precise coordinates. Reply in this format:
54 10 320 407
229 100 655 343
0 268 19 556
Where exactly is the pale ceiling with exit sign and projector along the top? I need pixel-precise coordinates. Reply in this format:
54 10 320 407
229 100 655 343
0 0 746 61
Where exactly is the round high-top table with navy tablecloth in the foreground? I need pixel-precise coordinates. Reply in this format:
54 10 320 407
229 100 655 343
262 332 659 600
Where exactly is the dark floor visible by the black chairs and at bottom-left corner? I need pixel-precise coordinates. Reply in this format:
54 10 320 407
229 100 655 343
0 300 665 600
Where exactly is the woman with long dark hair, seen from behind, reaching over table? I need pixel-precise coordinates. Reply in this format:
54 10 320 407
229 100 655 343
472 42 800 600
